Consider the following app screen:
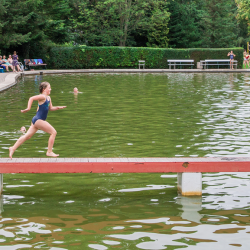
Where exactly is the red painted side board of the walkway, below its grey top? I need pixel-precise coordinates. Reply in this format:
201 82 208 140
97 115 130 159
0 161 250 173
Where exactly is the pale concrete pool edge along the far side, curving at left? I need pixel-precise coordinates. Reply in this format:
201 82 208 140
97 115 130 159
0 69 250 92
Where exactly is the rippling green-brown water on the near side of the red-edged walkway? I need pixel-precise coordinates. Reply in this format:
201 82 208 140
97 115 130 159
0 173 250 249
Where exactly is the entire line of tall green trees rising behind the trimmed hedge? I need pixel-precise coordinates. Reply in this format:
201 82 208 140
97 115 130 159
0 0 250 58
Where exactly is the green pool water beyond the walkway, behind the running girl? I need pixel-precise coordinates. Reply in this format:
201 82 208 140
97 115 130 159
0 74 250 157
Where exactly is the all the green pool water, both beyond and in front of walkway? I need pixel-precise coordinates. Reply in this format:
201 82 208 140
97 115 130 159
0 74 250 250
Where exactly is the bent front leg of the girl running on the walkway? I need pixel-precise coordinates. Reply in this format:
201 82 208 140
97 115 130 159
35 120 59 157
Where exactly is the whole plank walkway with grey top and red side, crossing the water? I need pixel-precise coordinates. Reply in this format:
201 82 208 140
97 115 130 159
0 157 250 173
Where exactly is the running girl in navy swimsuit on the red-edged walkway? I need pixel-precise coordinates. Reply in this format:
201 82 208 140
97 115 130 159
9 82 66 159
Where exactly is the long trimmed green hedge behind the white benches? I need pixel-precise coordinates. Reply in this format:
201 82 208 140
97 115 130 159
46 46 243 69
